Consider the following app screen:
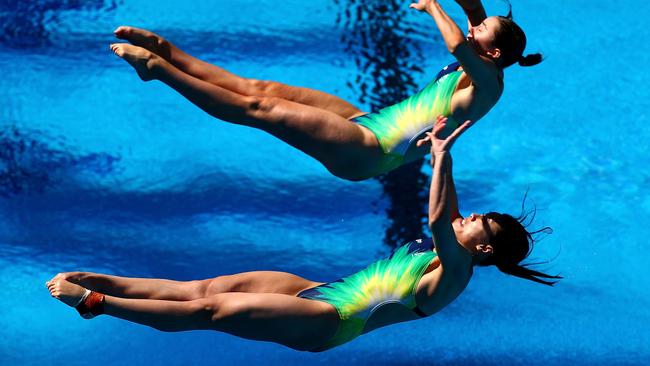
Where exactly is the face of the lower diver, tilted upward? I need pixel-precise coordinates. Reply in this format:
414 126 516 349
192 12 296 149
452 213 501 253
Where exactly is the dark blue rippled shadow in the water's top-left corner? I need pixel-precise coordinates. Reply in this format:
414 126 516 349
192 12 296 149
0 0 118 48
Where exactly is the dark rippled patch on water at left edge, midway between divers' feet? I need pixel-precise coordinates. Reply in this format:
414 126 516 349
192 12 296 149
0 125 120 198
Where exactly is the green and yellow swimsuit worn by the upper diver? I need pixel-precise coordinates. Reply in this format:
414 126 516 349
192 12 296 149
354 62 463 158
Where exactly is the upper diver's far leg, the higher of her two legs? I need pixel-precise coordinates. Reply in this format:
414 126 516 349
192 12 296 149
115 26 364 119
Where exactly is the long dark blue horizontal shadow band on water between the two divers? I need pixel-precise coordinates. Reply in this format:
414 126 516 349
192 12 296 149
2 173 375 223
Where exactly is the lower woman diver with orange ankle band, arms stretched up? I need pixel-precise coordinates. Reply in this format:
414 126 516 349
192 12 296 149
46 116 559 352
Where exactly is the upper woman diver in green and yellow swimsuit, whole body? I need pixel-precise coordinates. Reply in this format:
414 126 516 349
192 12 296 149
111 0 541 180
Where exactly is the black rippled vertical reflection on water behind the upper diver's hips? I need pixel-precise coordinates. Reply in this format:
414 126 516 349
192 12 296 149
334 0 428 246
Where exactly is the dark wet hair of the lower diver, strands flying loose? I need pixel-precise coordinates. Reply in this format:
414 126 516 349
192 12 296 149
479 209 562 286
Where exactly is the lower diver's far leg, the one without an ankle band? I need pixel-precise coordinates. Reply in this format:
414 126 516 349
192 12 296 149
52 271 320 301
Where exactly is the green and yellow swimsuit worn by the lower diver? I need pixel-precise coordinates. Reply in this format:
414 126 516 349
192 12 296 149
298 239 436 350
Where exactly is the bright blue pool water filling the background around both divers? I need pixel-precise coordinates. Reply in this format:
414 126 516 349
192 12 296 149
0 0 650 365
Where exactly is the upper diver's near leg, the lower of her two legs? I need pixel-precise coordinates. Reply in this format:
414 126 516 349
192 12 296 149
111 44 383 180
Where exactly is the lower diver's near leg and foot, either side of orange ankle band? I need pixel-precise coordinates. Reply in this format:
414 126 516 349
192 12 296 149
47 279 339 350
